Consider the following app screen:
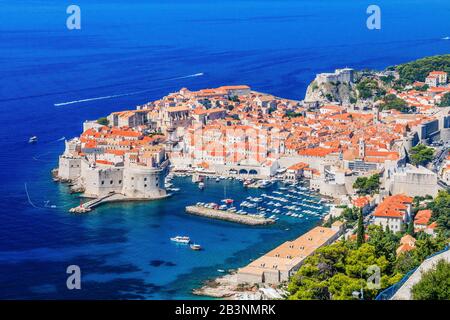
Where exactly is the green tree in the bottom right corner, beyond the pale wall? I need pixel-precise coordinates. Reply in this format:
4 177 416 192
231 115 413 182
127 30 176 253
412 260 450 300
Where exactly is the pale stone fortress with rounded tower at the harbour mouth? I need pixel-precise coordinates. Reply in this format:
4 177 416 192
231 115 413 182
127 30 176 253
57 127 168 199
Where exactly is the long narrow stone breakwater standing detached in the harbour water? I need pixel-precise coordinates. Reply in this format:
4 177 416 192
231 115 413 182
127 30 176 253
186 206 275 226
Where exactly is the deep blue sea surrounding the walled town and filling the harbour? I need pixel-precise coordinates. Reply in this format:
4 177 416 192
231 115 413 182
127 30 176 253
0 0 450 299
